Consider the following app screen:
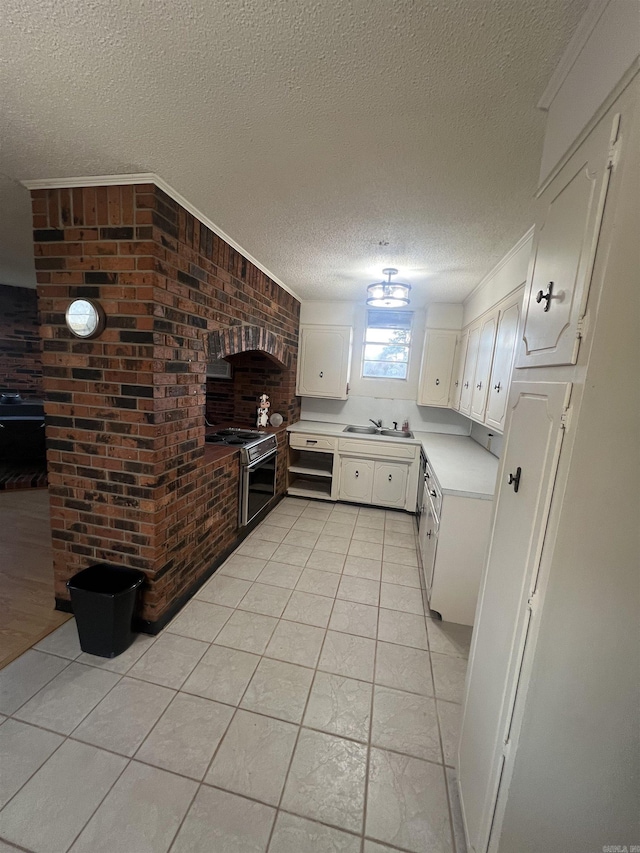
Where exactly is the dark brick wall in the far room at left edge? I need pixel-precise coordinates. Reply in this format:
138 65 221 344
0 284 42 397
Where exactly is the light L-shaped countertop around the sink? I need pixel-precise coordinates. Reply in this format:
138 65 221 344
287 421 498 500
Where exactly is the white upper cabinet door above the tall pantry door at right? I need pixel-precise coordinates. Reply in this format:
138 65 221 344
516 111 621 367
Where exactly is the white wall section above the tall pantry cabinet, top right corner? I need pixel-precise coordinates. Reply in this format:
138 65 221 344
540 0 640 183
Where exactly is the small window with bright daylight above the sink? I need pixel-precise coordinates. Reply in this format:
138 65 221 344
362 308 413 379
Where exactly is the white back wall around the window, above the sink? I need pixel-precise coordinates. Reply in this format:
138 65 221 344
300 301 470 435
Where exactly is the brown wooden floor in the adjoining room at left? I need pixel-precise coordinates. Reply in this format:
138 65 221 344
0 489 70 669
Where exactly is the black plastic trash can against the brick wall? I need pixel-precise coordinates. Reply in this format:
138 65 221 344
67 563 144 658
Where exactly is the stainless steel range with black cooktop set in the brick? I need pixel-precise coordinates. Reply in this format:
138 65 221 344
205 428 278 527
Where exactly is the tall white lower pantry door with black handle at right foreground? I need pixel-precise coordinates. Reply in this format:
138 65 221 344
458 382 571 853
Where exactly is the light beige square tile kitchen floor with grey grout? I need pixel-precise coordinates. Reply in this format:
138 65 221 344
0 498 471 853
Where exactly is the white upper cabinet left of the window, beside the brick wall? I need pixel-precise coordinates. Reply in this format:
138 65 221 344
296 326 353 400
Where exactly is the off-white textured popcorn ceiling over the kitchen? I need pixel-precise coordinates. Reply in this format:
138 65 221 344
0 0 587 305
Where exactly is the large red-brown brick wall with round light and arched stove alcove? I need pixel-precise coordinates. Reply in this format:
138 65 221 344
32 185 300 622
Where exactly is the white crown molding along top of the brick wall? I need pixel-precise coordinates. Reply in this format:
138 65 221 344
20 172 302 302
